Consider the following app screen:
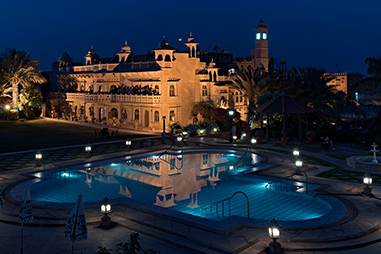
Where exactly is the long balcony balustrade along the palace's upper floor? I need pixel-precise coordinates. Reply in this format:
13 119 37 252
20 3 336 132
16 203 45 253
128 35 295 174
66 93 161 104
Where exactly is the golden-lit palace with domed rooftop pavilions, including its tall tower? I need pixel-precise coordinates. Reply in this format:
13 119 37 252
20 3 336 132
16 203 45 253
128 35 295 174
48 20 270 130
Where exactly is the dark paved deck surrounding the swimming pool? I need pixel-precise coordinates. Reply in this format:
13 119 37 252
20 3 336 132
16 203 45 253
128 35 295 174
0 138 381 254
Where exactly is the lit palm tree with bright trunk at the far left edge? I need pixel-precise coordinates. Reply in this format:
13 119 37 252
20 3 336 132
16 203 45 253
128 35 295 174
0 49 46 106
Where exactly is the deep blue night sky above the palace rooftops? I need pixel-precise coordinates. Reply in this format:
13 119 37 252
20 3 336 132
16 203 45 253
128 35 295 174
0 0 381 74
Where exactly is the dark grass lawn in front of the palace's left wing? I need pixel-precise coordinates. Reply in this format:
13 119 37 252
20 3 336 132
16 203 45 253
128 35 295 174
0 119 151 153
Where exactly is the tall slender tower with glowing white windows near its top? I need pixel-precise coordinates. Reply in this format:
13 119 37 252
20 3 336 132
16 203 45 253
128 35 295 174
251 19 269 72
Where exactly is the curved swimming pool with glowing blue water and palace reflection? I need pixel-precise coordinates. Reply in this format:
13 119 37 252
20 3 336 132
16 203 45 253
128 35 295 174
11 152 331 221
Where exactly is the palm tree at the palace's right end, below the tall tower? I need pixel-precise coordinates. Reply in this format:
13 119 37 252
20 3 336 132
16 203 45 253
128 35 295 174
231 67 269 123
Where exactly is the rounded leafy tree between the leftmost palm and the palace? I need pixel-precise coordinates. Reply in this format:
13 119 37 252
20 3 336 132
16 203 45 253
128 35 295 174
16 86 42 119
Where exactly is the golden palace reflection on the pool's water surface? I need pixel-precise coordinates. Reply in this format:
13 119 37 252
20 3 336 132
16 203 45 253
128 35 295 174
83 154 238 208
